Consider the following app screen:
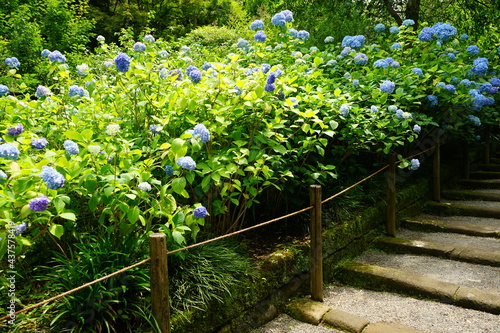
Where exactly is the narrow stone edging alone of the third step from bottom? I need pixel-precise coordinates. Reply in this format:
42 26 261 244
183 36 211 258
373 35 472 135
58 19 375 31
376 237 500 267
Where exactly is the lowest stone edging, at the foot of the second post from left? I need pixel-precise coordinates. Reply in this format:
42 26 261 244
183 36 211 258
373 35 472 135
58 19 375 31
286 298 423 333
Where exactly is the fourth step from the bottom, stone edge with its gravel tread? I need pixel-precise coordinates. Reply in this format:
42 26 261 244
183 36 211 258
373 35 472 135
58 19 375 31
401 215 500 238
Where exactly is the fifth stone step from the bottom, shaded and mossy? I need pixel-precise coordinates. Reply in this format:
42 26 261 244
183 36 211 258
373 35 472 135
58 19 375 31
424 200 500 219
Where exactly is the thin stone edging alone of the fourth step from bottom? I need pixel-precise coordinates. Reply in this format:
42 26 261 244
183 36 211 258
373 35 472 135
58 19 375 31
402 218 500 238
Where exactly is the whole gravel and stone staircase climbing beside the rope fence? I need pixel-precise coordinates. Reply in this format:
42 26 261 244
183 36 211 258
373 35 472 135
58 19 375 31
255 152 500 333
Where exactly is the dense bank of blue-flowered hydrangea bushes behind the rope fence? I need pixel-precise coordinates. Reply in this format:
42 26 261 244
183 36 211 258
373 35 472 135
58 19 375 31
0 11 500 331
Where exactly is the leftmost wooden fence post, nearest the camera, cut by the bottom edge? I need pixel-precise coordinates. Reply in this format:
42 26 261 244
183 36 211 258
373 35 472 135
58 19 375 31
149 233 170 333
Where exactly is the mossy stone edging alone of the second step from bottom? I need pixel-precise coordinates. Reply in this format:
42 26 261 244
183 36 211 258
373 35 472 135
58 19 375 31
341 262 500 314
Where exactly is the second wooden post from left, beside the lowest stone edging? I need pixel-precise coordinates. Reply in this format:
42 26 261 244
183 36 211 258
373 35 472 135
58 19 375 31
309 185 323 302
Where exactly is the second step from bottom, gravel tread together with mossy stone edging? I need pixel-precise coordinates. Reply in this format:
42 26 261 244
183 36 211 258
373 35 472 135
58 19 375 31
337 252 500 314
